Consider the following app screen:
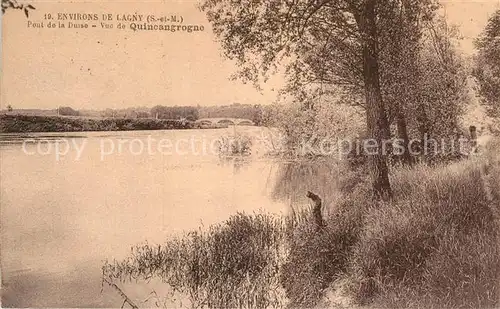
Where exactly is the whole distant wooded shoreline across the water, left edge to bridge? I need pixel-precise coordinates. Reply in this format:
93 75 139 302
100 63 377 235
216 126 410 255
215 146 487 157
0 103 269 132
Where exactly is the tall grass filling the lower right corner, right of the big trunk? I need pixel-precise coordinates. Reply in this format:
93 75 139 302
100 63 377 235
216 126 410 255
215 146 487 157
346 161 500 308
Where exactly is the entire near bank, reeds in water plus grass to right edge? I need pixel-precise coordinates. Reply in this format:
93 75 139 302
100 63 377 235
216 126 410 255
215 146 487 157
104 144 500 308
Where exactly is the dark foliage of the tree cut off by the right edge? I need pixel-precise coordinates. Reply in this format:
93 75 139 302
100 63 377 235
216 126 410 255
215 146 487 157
474 10 500 114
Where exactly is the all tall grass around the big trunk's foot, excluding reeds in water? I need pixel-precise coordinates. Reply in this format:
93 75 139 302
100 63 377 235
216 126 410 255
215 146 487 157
281 153 500 308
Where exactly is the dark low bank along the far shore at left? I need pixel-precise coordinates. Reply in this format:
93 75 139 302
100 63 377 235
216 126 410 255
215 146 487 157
0 115 193 133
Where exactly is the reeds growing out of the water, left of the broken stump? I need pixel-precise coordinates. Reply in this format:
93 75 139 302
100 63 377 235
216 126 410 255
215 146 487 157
103 213 292 308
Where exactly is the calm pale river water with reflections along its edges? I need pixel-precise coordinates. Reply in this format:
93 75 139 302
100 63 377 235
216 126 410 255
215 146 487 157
0 128 335 307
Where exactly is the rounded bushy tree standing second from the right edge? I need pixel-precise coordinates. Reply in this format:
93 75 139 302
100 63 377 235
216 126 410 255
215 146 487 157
413 19 468 136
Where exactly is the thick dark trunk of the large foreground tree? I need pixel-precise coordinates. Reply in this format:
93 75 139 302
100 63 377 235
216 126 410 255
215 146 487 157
356 0 392 199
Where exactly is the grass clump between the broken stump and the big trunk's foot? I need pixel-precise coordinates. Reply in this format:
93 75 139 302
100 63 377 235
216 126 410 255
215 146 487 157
281 192 370 308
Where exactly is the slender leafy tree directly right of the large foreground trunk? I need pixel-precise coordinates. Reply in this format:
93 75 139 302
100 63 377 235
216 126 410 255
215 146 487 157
380 1 437 165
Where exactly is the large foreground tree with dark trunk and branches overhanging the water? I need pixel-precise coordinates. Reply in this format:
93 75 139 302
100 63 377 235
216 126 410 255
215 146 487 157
201 0 455 196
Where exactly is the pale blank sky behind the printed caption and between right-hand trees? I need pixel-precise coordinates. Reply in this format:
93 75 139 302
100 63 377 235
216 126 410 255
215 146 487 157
0 0 500 109
